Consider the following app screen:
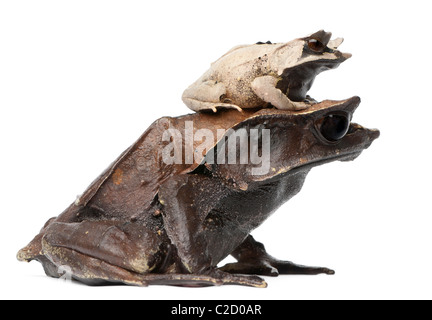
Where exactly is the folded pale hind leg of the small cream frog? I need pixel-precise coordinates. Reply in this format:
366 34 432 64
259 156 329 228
182 80 242 112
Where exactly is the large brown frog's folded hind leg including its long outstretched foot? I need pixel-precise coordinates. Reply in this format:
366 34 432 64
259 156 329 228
40 221 266 287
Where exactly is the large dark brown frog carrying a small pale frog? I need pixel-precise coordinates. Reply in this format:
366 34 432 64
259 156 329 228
18 97 379 287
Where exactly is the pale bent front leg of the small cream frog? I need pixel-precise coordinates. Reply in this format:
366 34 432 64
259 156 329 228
251 76 310 111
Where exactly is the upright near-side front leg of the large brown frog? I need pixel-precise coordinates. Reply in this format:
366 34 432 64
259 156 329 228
155 175 267 288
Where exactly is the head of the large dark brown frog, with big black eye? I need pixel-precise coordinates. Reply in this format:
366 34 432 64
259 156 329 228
251 96 380 181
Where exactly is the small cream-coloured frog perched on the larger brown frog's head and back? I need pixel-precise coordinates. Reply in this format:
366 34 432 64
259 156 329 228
182 30 351 112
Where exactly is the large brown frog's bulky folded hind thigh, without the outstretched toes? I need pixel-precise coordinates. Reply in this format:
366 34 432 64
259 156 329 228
42 221 164 286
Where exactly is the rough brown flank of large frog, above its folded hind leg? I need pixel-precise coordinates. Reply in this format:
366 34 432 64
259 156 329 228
77 117 187 219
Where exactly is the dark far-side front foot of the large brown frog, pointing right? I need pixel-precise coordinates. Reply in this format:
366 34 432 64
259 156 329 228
221 235 335 276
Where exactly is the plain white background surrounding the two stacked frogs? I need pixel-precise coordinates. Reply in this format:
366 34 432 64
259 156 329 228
0 0 432 299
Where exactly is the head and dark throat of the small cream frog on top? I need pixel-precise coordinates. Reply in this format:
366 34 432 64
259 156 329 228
277 30 352 103
